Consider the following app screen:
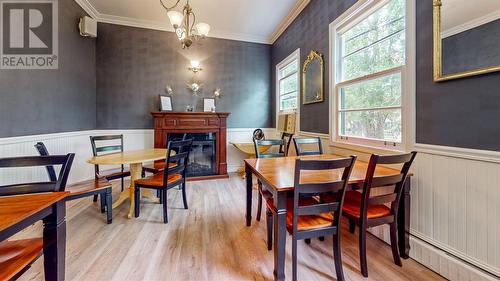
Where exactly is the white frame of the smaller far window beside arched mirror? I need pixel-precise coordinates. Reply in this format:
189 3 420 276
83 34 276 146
275 48 301 119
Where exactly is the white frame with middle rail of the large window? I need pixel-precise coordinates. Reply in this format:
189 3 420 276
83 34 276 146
329 0 414 151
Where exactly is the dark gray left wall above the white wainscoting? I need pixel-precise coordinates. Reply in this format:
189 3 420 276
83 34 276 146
0 0 96 137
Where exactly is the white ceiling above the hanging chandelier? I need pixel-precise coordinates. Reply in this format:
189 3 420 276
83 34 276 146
75 0 310 43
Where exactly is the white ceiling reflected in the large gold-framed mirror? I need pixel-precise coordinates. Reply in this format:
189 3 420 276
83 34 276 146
441 0 500 36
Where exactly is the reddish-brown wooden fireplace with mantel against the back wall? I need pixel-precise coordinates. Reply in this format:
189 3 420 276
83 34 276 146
151 112 229 180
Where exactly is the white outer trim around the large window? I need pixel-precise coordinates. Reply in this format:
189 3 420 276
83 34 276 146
329 0 416 152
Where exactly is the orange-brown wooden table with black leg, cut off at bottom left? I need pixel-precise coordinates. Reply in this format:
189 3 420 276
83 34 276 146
0 192 69 280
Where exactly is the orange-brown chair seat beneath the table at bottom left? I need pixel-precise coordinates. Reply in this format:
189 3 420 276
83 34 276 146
0 238 43 280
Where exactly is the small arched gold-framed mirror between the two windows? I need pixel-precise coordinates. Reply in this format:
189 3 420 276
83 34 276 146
302 50 325 104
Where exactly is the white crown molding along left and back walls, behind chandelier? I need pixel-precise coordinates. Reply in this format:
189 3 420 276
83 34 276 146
75 0 272 44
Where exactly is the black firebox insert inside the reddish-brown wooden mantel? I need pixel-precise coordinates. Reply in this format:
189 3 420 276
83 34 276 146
168 133 217 177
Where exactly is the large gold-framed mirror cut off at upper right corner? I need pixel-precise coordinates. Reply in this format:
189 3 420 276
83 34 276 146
433 0 500 82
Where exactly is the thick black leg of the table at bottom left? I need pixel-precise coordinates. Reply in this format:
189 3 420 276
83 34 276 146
43 200 66 281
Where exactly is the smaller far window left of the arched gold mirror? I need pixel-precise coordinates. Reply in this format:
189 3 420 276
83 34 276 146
276 50 300 113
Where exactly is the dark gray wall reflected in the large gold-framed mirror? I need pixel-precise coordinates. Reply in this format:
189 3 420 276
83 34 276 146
442 20 500 74
